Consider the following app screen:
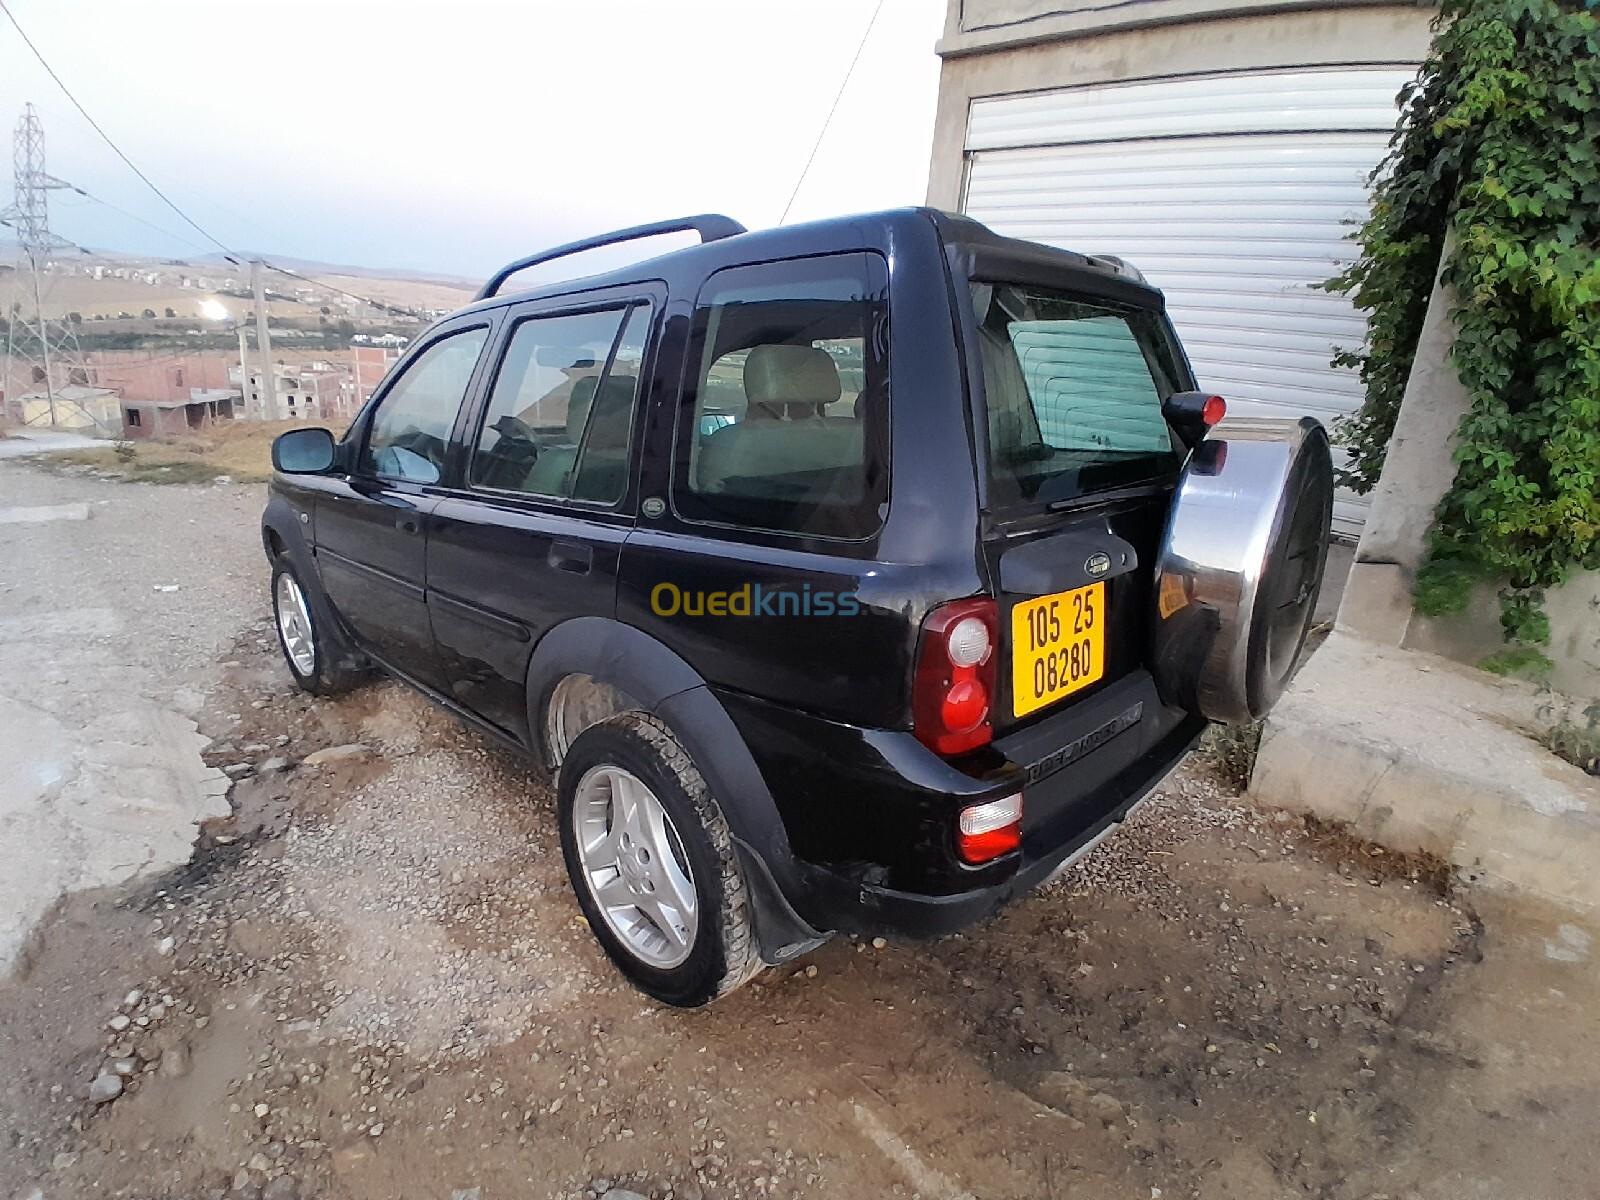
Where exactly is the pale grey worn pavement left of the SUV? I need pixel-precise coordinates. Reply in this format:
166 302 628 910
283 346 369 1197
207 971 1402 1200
0 467 262 971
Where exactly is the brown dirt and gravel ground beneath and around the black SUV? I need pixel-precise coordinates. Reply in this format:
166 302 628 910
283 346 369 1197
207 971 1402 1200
0 467 1600 1200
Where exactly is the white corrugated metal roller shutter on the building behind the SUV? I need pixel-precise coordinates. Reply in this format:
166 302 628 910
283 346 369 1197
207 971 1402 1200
965 67 1414 531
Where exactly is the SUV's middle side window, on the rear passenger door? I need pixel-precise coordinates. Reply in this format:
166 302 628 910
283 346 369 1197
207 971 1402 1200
472 304 650 502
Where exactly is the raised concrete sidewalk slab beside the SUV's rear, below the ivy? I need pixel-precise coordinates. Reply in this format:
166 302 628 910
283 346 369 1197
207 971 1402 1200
1250 632 1600 912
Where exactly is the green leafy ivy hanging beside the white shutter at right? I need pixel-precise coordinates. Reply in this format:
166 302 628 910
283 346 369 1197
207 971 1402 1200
1328 0 1600 645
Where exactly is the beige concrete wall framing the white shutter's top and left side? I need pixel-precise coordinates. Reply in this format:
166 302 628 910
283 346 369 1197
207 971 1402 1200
928 0 1434 211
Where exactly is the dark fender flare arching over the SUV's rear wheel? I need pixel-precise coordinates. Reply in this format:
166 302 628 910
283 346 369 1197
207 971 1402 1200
528 616 827 963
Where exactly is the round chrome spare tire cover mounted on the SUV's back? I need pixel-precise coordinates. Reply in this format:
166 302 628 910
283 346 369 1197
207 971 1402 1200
1150 418 1333 722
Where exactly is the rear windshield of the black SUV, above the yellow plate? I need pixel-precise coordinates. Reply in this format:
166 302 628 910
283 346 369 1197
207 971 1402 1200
973 283 1179 507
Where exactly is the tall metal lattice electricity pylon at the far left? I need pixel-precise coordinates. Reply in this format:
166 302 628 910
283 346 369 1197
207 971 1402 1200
0 104 93 426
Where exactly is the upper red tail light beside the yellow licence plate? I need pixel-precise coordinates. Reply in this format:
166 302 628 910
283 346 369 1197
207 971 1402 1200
912 597 998 755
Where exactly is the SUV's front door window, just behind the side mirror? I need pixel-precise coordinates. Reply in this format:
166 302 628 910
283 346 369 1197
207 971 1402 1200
360 328 488 483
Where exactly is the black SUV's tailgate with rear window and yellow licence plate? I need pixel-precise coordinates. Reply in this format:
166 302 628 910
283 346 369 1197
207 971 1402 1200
971 280 1186 733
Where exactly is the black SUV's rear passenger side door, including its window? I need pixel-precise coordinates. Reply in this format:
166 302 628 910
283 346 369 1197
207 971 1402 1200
427 285 666 738
